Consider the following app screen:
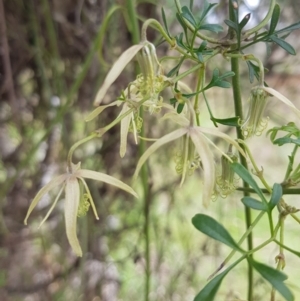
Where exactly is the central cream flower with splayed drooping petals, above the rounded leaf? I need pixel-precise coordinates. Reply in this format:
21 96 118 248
133 103 246 206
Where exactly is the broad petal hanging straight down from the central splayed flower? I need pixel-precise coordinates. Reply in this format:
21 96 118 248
190 128 215 206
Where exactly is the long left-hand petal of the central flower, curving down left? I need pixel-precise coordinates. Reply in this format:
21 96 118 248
133 128 188 179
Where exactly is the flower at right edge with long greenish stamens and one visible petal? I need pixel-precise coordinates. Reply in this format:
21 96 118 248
241 86 300 138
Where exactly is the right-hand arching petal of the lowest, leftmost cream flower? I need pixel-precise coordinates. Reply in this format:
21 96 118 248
76 169 138 197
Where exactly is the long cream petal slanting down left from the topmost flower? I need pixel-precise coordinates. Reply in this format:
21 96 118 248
94 44 144 106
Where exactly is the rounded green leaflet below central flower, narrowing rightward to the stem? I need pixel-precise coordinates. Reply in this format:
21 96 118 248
192 214 243 252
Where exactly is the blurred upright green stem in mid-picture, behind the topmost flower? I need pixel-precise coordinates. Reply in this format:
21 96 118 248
126 0 151 301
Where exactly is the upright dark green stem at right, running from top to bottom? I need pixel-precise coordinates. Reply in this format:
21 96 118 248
229 1 253 301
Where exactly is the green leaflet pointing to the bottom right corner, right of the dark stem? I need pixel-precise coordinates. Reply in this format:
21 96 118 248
249 259 295 301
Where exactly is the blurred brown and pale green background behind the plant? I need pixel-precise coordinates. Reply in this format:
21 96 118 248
0 0 300 301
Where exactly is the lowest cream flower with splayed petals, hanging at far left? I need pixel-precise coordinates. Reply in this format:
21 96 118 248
24 162 137 256
